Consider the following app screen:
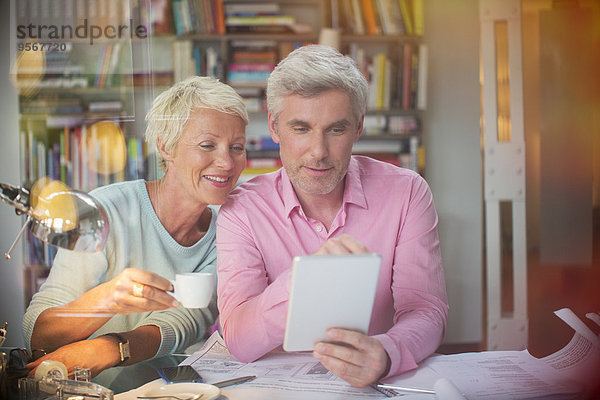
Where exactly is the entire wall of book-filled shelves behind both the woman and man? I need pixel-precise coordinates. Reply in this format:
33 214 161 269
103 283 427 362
13 0 427 296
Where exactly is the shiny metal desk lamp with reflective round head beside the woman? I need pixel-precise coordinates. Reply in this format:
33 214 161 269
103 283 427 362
0 179 109 259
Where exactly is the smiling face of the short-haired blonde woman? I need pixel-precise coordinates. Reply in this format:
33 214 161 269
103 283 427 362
159 108 246 205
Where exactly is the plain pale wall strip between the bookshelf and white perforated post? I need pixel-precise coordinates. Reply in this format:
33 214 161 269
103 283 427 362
424 0 483 343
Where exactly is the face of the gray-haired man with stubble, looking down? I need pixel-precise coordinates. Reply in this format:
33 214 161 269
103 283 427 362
269 90 362 197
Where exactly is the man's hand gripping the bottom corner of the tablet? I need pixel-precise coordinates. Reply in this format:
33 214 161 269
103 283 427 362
313 328 390 387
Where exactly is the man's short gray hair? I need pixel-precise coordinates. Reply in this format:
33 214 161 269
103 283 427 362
267 45 368 123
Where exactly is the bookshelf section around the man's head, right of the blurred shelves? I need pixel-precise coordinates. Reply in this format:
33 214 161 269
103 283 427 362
164 0 427 179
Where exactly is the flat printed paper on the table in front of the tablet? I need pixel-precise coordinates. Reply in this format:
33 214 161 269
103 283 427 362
180 332 382 400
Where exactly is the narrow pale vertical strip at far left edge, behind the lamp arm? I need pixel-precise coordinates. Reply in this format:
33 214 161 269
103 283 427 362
0 1 25 346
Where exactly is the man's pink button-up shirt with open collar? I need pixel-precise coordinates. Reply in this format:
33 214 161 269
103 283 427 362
216 156 448 376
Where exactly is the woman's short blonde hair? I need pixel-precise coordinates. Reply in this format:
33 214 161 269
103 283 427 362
145 76 248 172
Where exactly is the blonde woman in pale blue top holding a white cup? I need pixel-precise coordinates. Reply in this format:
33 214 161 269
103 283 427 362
23 77 248 376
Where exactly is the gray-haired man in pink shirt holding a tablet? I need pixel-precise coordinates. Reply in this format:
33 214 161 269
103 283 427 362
216 45 448 387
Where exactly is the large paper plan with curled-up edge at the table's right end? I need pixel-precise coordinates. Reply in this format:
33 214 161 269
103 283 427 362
406 309 600 400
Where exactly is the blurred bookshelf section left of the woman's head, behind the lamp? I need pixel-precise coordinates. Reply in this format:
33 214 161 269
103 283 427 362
10 0 158 282
